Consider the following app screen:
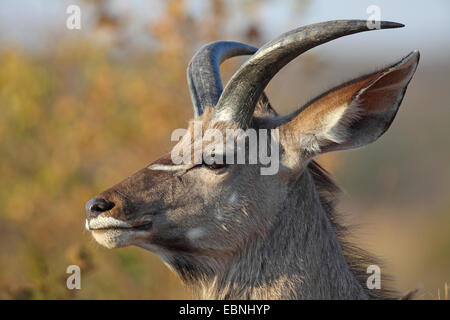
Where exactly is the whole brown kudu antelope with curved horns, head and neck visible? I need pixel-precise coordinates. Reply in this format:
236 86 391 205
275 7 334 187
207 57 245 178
86 20 419 299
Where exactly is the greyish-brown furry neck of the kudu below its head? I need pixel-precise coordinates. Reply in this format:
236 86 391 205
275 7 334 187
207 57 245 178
179 169 370 299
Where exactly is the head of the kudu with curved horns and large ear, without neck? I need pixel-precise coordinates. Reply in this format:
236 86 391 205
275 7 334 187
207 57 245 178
86 20 419 298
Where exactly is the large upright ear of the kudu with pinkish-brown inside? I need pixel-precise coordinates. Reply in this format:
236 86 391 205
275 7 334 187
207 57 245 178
279 51 419 165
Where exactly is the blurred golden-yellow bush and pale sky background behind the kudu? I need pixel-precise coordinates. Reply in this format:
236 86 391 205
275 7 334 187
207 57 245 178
0 0 450 299
